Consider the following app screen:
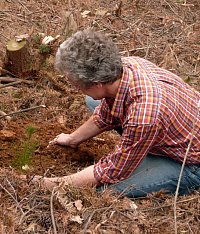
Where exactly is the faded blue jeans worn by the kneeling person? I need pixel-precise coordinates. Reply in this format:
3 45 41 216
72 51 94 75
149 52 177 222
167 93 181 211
86 97 200 197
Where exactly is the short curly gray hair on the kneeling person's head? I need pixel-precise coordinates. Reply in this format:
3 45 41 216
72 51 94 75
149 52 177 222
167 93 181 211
55 29 122 87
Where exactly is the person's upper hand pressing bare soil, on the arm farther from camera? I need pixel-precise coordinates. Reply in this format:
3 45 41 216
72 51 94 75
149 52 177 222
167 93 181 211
47 133 78 148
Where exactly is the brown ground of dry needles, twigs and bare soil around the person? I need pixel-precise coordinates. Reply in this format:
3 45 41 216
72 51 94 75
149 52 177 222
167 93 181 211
0 0 200 234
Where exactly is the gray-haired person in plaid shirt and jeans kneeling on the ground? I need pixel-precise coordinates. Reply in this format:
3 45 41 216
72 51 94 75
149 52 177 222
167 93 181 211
35 29 200 197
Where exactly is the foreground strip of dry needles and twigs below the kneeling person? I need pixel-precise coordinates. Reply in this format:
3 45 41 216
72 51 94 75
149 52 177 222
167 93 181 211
0 171 200 234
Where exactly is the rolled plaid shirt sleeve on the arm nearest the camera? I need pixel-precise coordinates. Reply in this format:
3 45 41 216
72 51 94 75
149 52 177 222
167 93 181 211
94 121 159 184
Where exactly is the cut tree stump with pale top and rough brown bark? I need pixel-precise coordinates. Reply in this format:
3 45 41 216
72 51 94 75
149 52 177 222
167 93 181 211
5 39 32 78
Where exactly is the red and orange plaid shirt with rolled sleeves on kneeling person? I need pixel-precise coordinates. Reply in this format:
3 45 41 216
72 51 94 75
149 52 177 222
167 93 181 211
93 57 200 183
